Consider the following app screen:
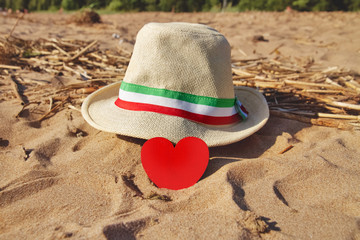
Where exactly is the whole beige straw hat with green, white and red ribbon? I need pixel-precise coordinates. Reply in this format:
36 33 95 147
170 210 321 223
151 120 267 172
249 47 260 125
81 23 269 147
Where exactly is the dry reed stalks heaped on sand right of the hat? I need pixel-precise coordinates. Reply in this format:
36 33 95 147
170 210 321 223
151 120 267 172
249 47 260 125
233 56 360 130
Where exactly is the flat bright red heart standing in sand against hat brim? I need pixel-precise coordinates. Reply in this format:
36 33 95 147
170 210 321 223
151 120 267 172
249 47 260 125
141 137 209 190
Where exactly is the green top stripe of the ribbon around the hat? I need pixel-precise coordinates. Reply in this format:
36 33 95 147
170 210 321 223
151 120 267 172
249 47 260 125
120 82 235 107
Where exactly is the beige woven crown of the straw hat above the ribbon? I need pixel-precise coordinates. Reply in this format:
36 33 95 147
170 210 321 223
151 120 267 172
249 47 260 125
124 23 234 98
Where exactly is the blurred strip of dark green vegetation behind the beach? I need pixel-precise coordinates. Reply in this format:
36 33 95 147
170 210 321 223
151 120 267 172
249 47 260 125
0 0 360 12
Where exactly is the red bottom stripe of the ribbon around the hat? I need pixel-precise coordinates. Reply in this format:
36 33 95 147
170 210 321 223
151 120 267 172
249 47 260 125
115 98 241 125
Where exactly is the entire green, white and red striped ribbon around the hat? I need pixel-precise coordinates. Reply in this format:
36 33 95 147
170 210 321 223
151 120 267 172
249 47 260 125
115 82 248 125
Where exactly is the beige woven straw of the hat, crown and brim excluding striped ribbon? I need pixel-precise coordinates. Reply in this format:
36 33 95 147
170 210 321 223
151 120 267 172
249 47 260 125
82 23 269 147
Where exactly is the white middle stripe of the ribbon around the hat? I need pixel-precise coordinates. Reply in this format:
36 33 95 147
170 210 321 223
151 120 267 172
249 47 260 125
119 89 237 117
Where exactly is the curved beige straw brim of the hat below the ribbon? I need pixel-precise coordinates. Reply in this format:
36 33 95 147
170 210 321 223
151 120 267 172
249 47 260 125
81 82 269 147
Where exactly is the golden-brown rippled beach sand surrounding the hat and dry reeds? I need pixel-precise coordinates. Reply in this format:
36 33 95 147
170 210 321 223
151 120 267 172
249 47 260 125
0 12 360 239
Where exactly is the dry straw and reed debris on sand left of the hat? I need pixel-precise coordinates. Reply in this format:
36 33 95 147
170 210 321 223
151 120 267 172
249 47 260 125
0 35 130 122
